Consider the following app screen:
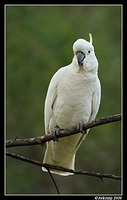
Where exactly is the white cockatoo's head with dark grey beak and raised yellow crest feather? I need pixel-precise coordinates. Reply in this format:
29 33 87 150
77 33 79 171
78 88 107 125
73 34 98 73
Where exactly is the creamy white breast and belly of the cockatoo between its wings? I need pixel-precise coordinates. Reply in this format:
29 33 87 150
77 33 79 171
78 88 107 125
53 68 93 128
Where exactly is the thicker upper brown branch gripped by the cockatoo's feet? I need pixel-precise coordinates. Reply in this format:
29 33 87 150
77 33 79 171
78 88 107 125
6 114 121 147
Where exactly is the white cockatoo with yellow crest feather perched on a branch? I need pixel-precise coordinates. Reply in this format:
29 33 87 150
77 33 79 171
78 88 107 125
42 34 101 176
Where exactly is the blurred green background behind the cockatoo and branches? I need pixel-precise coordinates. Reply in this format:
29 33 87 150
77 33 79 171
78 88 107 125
6 6 121 194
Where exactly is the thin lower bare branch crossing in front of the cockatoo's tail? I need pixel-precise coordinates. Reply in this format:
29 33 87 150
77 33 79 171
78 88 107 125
6 152 121 180
